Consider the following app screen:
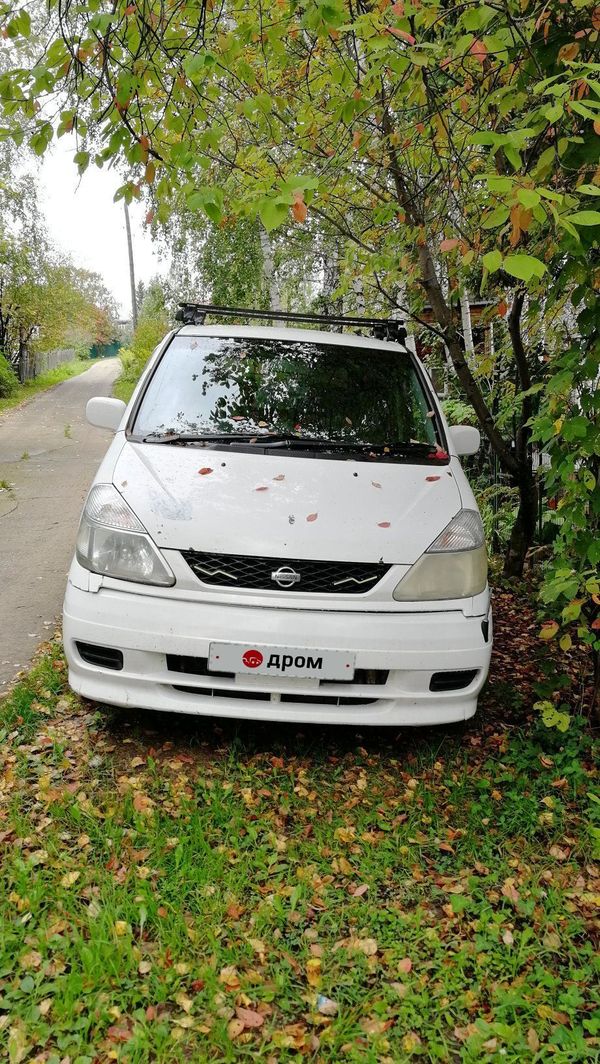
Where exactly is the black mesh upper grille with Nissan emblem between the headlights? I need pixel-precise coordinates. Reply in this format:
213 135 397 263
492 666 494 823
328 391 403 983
182 550 389 595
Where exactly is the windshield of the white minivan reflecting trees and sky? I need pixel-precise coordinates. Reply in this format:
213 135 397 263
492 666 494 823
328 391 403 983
133 335 436 448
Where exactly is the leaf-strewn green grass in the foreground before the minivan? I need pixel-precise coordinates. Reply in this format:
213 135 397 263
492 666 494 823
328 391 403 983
0 593 600 1064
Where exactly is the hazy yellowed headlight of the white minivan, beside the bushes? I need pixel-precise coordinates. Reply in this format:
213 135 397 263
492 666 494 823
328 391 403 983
394 510 487 602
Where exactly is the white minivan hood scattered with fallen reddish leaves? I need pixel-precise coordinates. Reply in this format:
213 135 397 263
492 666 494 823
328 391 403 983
113 443 461 565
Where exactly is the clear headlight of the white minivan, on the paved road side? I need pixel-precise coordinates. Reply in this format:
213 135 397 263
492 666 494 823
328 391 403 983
76 484 174 587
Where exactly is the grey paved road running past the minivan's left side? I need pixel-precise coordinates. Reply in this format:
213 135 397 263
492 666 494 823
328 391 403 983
0 359 119 695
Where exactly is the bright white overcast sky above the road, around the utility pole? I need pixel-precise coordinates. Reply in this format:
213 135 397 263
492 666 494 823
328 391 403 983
39 136 167 318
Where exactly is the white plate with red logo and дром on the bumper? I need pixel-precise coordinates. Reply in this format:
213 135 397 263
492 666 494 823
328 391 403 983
209 643 354 680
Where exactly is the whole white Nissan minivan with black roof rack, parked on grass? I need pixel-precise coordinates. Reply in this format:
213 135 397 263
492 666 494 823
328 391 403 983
64 304 491 727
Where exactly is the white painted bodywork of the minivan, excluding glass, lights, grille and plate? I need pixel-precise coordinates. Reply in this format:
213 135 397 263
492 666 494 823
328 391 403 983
64 326 491 725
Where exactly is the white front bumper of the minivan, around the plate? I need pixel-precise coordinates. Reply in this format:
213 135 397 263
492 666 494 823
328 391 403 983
64 582 491 726
